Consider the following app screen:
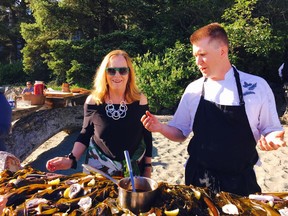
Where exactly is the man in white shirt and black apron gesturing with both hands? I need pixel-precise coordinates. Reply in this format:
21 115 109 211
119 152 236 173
141 23 286 196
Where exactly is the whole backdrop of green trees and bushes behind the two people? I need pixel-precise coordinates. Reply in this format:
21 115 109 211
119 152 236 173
0 0 288 112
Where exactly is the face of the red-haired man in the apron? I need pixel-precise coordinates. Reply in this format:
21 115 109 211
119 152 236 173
193 37 223 79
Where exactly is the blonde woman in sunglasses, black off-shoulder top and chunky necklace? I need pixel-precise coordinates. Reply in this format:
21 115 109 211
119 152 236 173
46 50 152 177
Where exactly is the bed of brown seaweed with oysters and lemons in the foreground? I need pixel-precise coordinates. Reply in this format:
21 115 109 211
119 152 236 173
0 166 288 216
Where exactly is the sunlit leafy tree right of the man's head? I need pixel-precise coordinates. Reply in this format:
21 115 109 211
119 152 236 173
222 0 283 80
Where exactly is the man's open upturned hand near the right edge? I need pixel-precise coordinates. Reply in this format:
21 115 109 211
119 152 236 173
257 131 286 151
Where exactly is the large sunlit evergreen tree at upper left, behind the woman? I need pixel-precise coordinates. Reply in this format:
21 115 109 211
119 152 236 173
21 0 146 83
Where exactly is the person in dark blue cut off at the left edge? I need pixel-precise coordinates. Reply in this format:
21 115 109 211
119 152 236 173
0 87 12 151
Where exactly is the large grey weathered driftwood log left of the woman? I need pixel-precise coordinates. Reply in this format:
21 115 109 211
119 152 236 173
5 105 83 161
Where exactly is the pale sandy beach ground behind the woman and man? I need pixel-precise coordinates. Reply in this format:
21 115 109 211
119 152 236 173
22 116 288 193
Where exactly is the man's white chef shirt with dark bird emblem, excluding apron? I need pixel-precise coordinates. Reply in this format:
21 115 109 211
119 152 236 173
168 68 283 141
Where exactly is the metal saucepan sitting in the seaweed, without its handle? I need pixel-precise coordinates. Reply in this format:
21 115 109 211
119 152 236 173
118 176 158 214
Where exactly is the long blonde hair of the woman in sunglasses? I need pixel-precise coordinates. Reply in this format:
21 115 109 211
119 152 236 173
91 50 141 105
